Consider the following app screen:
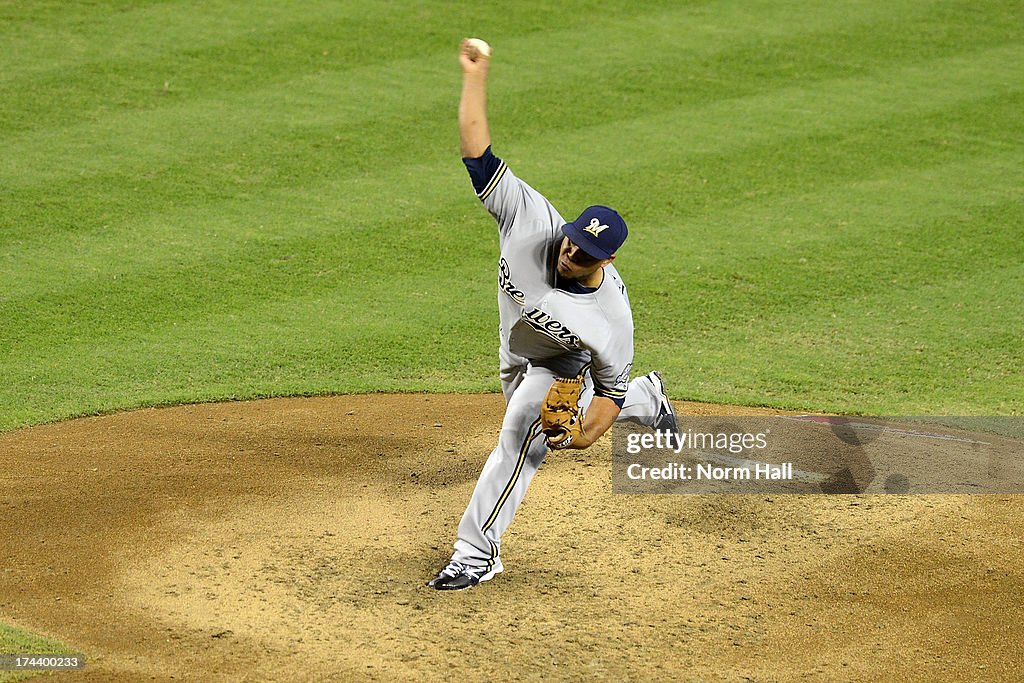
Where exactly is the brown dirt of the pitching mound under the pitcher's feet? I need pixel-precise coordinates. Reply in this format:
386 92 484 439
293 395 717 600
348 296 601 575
0 394 1024 681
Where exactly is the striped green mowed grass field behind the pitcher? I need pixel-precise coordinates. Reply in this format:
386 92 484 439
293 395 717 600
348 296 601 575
0 0 1024 430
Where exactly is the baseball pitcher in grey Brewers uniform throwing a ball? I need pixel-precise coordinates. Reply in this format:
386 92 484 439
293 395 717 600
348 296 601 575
427 39 678 590
